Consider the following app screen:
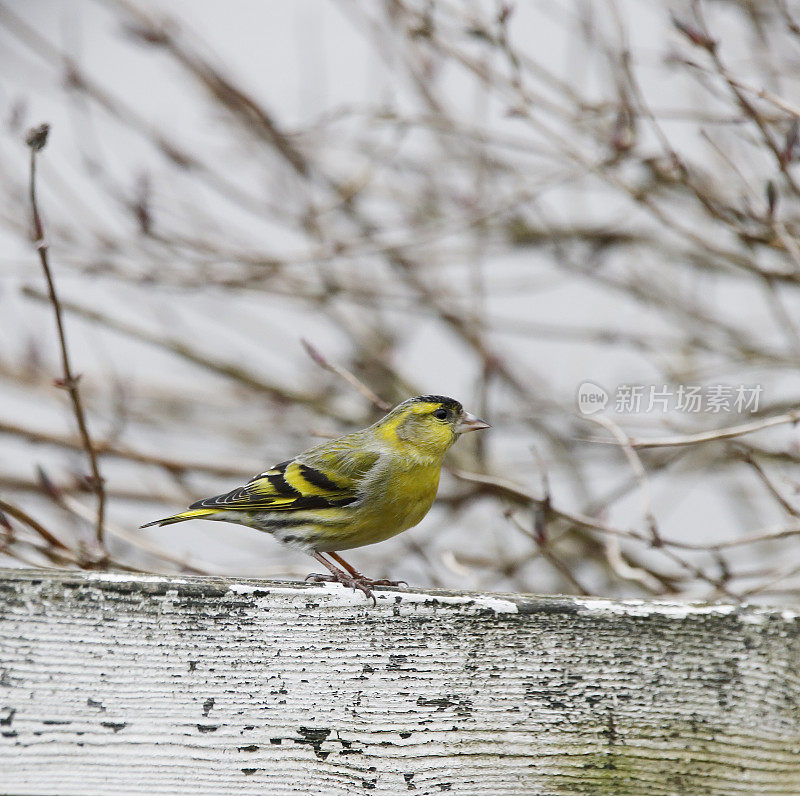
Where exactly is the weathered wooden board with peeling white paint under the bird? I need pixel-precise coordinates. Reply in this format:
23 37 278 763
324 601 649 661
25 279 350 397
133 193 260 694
0 570 800 796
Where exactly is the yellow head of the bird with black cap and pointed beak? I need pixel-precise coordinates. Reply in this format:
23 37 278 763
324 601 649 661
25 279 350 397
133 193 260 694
377 395 490 458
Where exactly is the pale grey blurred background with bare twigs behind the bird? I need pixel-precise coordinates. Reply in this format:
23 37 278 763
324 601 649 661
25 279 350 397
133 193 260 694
0 0 800 600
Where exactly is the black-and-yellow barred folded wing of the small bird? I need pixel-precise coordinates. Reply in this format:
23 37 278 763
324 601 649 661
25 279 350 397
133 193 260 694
190 448 380 511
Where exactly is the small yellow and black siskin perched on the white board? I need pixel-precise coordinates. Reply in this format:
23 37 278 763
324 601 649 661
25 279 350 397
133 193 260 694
142 395 489 602
